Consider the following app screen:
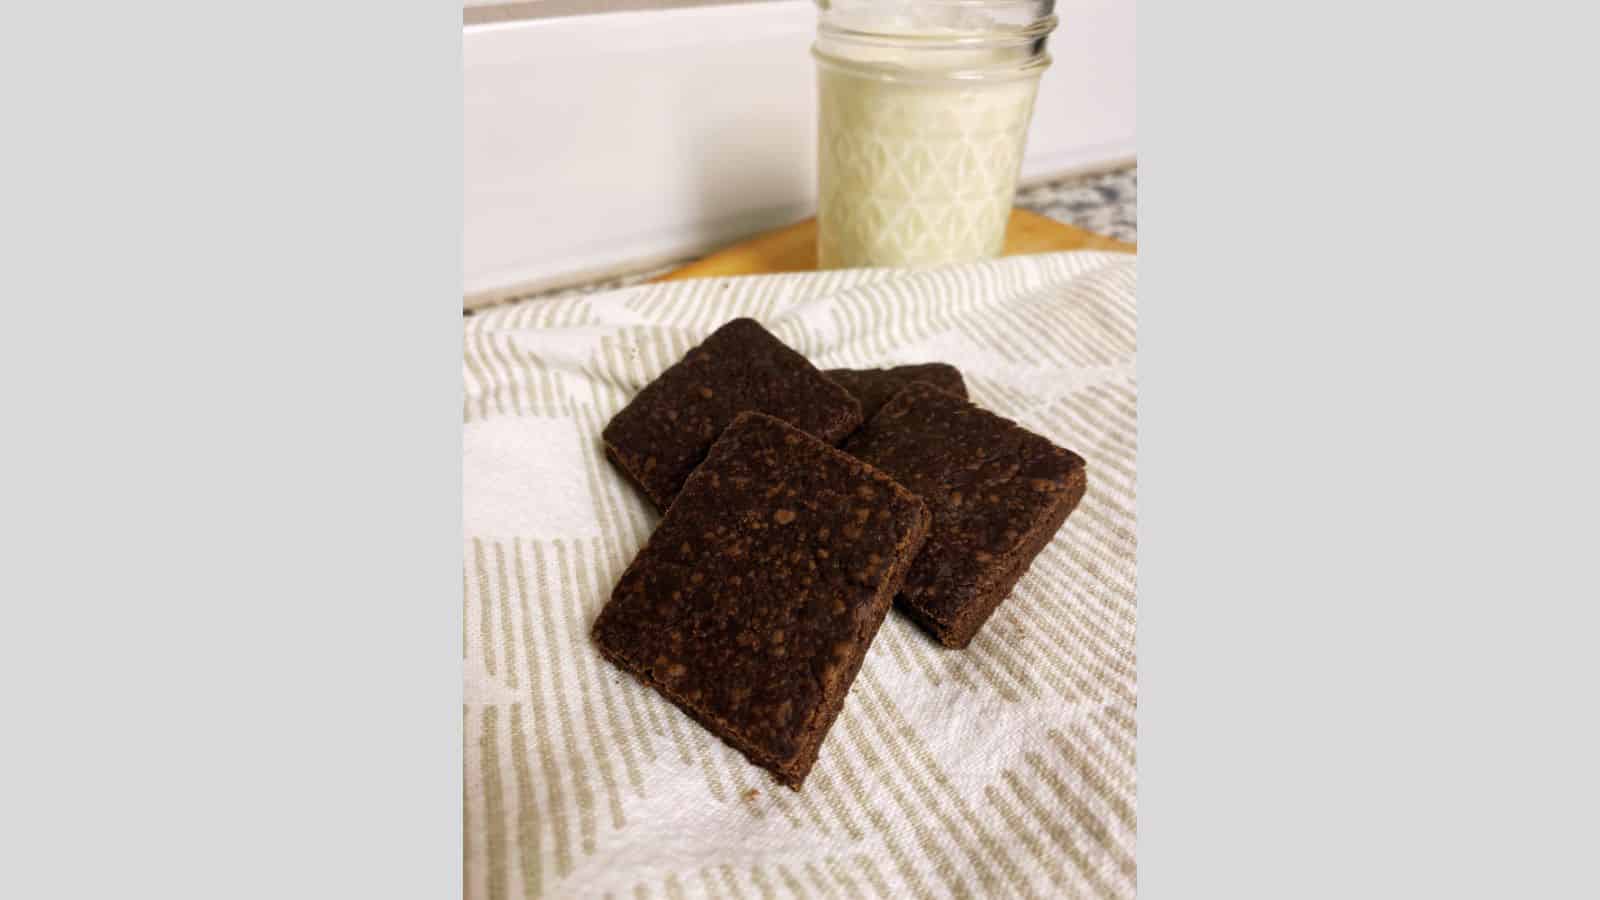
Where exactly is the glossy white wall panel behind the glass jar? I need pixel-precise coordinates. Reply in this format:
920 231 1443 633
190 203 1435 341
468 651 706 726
462 0 1134 304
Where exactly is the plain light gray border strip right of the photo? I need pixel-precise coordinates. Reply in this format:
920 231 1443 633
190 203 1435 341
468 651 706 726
1139 0 1600 898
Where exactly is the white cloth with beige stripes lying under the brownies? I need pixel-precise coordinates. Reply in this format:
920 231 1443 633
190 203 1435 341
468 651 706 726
462 251 1138 900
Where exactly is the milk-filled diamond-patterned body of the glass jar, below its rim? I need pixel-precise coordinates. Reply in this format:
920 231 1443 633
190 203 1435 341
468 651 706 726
818 66 1038 269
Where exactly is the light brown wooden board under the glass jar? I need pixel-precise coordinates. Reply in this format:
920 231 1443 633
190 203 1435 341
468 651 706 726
653 210 1138 282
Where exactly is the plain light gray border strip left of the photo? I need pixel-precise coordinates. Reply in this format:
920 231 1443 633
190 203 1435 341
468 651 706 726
0 0 462 898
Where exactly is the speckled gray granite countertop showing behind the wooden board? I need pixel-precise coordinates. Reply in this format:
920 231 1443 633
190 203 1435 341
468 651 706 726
469 165 1139 307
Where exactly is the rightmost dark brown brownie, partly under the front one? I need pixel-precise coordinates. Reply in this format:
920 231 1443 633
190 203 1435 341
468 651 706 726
845 383 1088 647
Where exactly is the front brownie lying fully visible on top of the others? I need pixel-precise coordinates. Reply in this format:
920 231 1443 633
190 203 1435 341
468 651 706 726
594 412 928 790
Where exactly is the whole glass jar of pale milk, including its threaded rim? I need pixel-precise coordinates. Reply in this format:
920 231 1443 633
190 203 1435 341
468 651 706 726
811 0 1056 269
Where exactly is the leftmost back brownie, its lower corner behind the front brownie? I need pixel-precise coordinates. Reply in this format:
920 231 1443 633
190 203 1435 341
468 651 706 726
602 319 862 511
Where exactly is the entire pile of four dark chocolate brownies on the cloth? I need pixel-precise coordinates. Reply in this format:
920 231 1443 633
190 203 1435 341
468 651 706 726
594 319 1086 790
